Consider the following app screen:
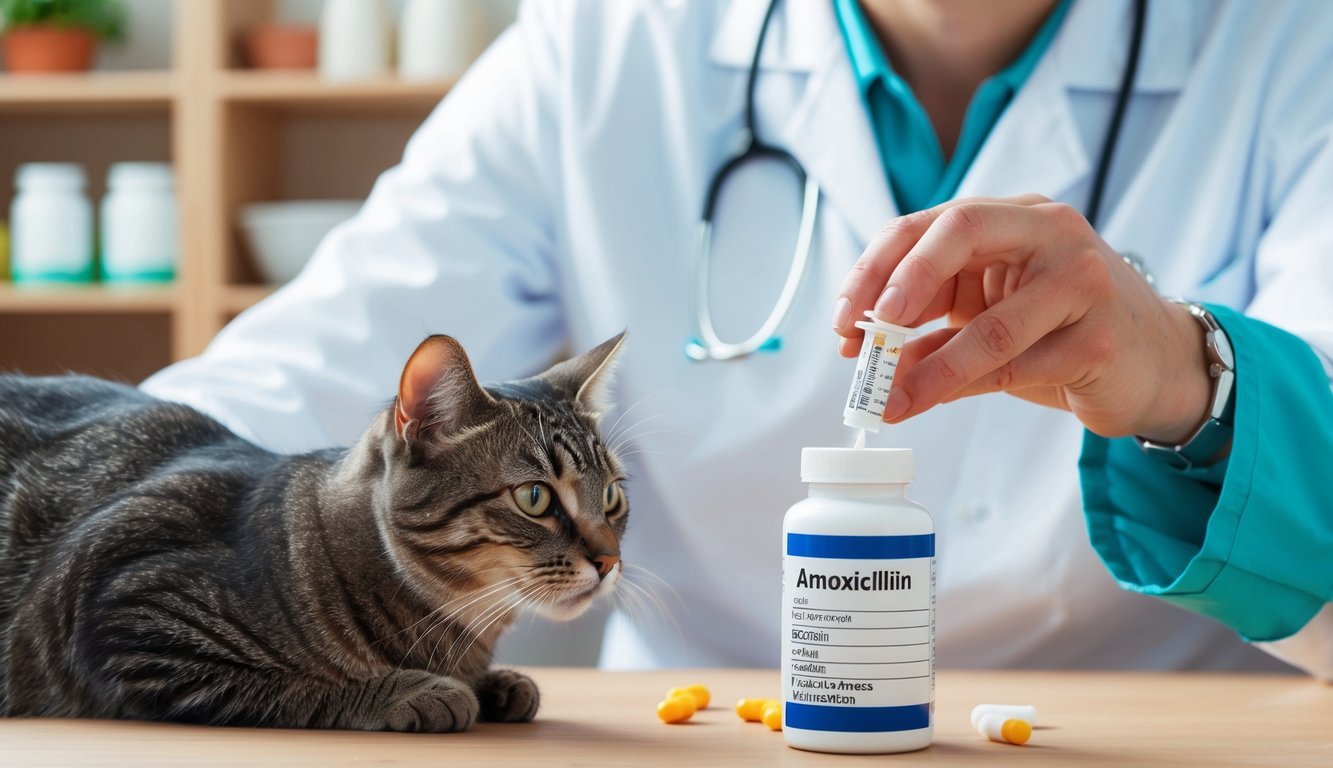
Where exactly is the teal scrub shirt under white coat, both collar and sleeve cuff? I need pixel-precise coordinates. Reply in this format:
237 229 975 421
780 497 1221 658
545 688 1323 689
834 0 1333 641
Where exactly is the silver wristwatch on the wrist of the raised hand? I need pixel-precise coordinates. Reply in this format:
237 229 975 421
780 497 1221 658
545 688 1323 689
1134 299 1236 469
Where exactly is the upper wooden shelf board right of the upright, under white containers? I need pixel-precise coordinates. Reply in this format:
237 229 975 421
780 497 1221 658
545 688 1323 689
219 71 453 113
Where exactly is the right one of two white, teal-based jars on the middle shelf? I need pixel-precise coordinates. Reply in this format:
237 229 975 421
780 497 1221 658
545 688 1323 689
101 163 180 283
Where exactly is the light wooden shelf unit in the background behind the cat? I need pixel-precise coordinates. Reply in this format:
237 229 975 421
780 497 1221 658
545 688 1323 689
0 0 452 381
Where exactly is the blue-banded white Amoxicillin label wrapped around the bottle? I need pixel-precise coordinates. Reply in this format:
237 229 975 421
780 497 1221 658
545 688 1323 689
782 533 934 732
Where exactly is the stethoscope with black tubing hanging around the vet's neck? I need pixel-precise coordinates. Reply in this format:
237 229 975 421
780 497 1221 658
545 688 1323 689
685 0 1148 361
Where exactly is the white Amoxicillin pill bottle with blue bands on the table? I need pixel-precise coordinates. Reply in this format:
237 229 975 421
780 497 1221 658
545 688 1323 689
780 448 934 753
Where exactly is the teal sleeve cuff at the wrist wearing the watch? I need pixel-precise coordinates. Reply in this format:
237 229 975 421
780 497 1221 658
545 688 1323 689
1078 305 1333 641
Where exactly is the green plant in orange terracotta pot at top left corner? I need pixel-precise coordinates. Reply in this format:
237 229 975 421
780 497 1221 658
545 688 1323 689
0 0 125 72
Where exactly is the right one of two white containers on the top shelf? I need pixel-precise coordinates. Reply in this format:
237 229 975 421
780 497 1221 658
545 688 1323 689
399 0 491 80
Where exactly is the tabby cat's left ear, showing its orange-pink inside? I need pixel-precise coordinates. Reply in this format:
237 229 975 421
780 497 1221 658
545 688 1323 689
393 336 496 444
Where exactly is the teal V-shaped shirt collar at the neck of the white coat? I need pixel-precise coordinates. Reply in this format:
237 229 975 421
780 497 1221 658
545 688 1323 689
834 0 1070 213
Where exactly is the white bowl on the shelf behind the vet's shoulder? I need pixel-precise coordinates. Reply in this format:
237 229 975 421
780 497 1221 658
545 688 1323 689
240 200 364 283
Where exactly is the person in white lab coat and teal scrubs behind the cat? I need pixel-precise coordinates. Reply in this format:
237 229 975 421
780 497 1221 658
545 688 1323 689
145 0 1333 677
